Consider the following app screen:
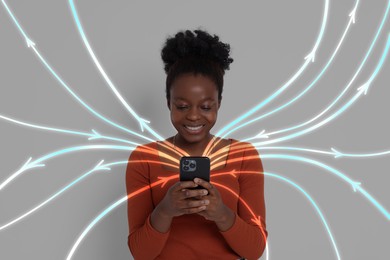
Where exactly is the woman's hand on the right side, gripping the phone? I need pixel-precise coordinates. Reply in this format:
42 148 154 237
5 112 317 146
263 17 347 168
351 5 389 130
194 178 235 229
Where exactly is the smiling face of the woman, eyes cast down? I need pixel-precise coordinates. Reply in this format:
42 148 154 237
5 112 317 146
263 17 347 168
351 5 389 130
168 73 220 143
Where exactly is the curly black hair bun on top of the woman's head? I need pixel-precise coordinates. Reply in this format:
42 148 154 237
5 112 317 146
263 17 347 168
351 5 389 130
161 30 233 74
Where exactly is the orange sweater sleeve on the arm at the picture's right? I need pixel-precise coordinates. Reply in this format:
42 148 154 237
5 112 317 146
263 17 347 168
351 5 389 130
221 143 268 259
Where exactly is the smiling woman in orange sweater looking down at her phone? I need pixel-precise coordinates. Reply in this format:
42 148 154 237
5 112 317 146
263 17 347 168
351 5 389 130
126 30 268 259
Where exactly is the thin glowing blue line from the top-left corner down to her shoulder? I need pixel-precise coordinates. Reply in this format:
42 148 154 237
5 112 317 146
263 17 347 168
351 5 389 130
2 0 154 141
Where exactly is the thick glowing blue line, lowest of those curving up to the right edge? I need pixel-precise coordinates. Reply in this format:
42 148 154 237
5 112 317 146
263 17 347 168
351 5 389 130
254 32 390 146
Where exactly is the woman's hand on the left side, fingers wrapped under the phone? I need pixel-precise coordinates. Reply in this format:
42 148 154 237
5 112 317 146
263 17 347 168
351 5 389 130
158 181 210 218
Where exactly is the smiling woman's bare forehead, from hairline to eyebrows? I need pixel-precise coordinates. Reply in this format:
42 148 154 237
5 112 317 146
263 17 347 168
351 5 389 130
170 74 218 100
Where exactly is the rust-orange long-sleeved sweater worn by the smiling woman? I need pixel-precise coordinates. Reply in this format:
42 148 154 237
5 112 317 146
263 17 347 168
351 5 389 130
126 139 268 260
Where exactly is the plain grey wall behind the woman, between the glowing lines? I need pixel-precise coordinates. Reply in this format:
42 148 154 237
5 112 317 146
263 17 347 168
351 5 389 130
0 0 390 259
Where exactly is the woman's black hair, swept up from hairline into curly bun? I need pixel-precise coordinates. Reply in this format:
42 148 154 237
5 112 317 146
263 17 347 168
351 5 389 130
161 30 233 101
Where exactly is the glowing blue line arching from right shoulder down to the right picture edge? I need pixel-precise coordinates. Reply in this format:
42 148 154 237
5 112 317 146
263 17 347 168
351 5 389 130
261 154 390 220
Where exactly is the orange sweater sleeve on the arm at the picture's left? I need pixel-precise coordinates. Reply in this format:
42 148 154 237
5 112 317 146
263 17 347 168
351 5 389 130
126 147 169 259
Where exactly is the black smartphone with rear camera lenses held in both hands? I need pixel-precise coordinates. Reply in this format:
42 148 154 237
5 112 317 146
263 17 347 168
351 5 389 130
180 156 210 189
